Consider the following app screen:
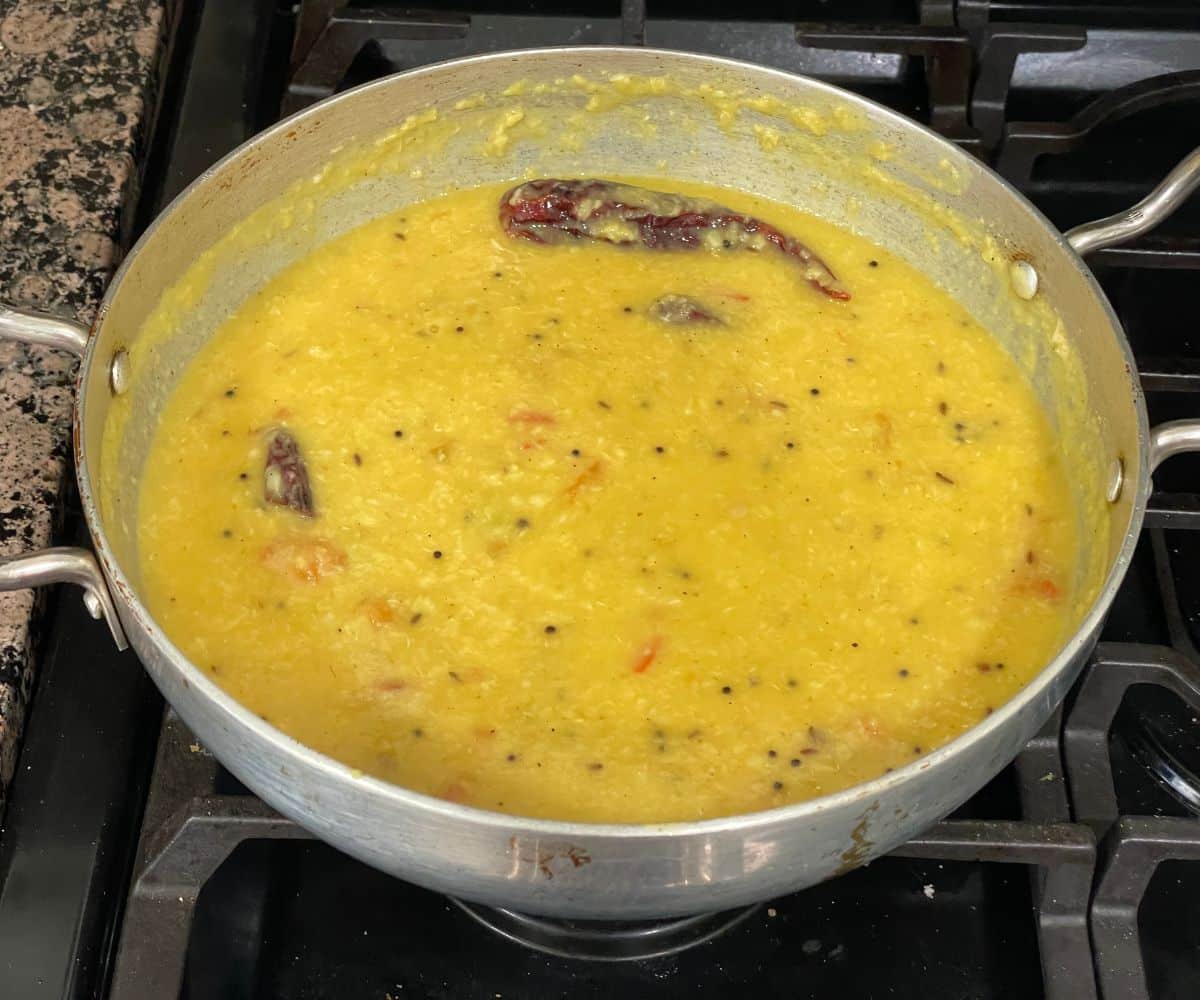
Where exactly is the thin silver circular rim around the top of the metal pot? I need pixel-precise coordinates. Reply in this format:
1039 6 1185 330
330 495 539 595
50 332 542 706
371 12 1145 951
73 46 1150 842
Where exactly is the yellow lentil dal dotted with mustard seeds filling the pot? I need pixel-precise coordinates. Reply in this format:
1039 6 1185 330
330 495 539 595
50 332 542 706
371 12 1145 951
138 179 1078 822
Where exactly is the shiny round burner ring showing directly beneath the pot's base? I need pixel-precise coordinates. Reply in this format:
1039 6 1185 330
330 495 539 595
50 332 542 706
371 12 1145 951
451 897 758 962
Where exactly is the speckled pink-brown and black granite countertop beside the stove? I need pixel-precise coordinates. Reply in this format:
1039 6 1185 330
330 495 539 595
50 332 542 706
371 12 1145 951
0 0 167 815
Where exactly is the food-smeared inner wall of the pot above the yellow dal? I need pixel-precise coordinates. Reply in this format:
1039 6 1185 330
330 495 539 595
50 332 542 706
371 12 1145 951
82 49 1144 629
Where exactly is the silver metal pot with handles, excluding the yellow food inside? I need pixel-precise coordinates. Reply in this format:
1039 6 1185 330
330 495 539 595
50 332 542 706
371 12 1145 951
0 48 1200 918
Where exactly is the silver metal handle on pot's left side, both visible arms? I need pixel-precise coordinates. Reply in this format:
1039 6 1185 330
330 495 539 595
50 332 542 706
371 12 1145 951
0 306 130 649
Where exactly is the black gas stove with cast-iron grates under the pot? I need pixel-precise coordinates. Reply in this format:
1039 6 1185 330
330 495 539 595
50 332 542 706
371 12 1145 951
0 0 1200 1000
